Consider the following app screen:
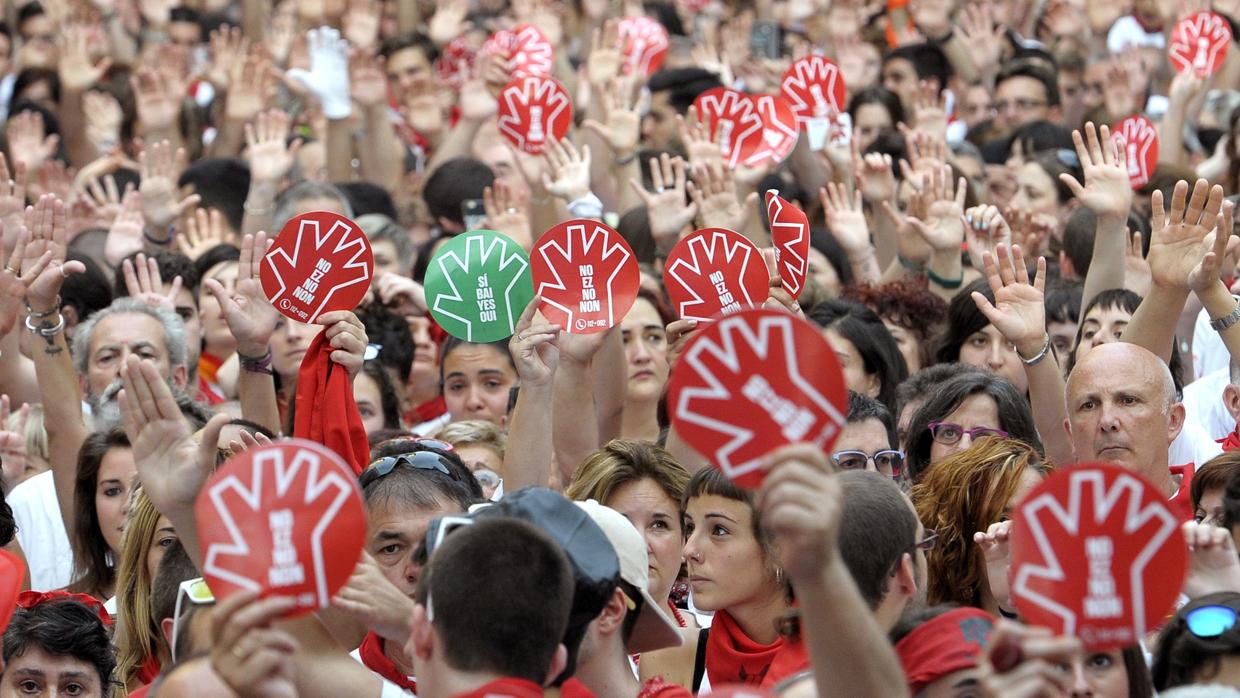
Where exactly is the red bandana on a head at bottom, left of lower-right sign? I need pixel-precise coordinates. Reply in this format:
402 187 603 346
897 607 994 696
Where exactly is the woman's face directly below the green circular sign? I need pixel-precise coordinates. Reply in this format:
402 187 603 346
444 345 517 426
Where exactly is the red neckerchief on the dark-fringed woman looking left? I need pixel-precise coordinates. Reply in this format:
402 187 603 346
706 611 810 687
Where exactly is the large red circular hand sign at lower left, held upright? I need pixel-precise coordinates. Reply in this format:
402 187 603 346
193 439 366 615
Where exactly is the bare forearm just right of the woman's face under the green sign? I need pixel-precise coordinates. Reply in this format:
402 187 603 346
503 386 554 492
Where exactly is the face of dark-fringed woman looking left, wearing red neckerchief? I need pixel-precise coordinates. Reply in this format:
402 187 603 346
684 495 779 611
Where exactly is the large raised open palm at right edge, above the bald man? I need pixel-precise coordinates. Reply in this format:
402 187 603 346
1146 180 1231 291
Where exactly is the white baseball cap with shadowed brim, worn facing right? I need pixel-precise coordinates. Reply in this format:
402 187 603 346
574 500 684 653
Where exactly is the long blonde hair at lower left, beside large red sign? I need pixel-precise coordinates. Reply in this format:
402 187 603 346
114 487 167 687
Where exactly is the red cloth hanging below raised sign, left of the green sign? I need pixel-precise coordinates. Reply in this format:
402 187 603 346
293 332 371 475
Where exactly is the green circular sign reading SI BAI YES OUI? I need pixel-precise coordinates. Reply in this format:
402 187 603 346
424 231 534 342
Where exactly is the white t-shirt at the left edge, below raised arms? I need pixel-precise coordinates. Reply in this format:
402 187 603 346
5 470 73 591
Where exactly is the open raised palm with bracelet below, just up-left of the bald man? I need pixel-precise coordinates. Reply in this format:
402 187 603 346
972 244 1047 358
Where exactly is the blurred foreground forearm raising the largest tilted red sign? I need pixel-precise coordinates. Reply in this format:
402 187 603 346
792 552 909 698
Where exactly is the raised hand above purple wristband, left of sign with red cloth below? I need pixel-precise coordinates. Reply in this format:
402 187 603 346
203 233 280 358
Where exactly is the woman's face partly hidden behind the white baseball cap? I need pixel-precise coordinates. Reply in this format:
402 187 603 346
606 477 684 601
